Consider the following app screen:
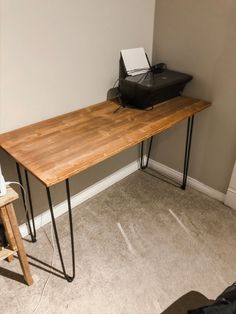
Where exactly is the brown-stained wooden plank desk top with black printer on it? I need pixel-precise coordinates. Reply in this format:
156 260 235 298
0 97 210 187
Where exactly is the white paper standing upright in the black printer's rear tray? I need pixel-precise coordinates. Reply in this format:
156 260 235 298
121 48 150 76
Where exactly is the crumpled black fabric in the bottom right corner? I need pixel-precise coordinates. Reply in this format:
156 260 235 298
188 283 236 314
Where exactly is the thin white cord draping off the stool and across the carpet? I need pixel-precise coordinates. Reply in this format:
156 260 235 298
6 182 55 314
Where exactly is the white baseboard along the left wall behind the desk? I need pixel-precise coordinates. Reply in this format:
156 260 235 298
20 161 139 237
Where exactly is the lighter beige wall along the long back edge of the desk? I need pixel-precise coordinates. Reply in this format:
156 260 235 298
0 0 155 218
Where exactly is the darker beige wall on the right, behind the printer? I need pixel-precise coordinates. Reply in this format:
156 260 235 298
153 0 236 192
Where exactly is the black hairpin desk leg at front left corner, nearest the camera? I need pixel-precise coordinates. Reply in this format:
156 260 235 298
46 179 75 282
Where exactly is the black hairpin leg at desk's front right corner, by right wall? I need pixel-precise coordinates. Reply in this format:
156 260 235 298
181 115 194 190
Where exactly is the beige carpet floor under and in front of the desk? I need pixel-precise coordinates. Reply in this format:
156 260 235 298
0 171 236 314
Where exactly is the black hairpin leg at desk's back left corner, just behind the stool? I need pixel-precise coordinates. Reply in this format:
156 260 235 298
16 162 36 242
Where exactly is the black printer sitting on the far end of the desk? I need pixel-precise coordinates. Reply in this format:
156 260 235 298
119 57 192 109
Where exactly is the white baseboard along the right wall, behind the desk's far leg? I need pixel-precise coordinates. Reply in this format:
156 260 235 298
149 159 225 202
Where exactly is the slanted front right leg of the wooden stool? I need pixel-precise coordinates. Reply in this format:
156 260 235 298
6 204 33 286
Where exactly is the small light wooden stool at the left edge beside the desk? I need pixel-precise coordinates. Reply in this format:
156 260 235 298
0 187 33 286
